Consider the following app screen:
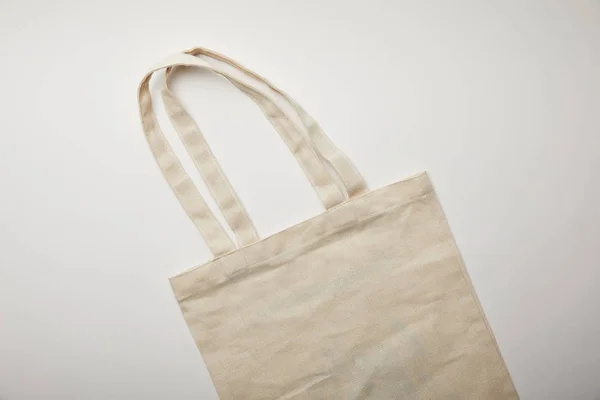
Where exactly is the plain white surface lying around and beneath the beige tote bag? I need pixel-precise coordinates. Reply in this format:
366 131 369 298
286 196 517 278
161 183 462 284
0 0 600 400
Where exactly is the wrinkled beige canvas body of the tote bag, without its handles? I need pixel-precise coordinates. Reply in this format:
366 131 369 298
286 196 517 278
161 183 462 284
171 175 517 400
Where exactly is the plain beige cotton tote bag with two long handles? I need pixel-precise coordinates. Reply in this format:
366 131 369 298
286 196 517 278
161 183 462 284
139 48 518 400
